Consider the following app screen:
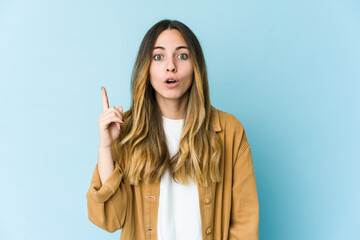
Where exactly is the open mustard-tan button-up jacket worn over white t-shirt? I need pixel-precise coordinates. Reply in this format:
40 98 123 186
86 107 259 240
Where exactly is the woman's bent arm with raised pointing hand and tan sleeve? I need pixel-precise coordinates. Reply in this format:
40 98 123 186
86 87 131 232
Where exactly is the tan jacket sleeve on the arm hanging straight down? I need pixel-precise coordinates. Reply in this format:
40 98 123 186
229 141 259 240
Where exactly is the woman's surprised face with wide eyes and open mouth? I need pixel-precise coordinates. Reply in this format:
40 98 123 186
149 29 194 102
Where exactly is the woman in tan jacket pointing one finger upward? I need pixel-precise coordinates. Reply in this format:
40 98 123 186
86 20 259 240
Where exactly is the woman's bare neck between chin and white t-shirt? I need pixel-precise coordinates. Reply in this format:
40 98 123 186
156 94 189 119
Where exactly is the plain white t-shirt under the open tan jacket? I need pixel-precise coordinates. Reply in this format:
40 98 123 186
158 117 202 240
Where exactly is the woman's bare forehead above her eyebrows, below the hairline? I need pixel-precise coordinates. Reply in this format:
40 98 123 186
154 29 187 48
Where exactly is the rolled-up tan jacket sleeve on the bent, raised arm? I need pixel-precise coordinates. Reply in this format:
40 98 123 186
86 162 129 232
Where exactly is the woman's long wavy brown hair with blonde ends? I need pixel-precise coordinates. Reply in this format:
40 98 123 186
113 20 221 186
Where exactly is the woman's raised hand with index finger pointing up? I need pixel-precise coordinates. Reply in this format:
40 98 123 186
99 87 124 148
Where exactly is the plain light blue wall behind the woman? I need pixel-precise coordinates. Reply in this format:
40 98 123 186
0 0 360 240
